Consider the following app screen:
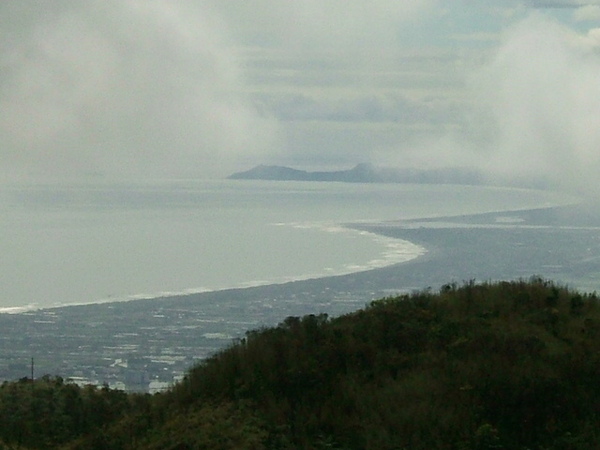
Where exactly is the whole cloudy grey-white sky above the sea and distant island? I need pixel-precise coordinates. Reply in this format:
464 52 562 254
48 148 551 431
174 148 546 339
0 0 600 191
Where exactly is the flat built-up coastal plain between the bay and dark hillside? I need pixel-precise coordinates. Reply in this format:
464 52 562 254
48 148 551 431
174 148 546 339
0 203 600 392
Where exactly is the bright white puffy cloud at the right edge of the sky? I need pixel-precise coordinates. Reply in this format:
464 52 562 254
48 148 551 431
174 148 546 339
474 15 600 189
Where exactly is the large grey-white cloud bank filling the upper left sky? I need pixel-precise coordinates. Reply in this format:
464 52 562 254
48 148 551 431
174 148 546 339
0 0 276 181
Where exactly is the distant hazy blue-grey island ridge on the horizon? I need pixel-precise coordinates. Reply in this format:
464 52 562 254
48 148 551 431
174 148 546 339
228 163 486 185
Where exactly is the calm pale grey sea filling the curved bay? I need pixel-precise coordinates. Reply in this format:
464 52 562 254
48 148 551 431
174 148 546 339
0 180 570 311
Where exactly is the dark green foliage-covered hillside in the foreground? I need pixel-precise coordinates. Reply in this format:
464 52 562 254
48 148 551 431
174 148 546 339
0 278 600 450
